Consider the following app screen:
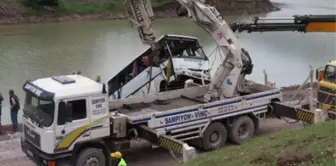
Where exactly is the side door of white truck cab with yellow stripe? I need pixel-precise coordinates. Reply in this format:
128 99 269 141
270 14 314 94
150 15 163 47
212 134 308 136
55 97 90 152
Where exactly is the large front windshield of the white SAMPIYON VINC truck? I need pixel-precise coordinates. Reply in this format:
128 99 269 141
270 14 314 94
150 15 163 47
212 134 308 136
23 93 55 127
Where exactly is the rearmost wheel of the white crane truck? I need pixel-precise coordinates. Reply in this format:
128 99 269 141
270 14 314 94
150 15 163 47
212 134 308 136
229 116 254 144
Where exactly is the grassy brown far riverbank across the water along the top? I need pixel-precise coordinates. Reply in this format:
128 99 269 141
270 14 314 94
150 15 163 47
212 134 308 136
0 0 279 25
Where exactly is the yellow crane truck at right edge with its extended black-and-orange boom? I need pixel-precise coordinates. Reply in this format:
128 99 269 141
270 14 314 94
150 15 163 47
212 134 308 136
230 15 336 119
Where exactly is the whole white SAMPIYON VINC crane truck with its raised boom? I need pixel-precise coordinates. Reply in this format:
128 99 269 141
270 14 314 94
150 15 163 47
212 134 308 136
21 0 336 166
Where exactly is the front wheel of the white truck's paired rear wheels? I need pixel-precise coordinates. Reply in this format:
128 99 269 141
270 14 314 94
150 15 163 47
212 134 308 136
201 122 227 151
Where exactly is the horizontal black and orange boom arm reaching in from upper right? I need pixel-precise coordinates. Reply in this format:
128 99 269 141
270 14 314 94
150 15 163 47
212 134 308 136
230 15 336 33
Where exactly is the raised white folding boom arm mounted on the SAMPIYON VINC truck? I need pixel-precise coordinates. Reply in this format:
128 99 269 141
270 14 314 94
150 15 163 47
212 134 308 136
122 0 253 101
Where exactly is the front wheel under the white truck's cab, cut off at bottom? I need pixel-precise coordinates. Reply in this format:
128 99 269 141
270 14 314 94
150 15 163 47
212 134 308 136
76 148 106 166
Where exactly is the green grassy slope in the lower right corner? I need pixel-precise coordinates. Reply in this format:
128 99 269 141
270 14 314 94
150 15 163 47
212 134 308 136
184 121 336 166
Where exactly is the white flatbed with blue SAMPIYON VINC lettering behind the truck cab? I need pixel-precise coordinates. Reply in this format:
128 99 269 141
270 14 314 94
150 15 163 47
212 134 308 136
111 84 281 129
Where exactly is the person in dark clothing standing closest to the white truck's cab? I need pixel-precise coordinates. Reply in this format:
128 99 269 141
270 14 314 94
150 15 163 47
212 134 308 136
9 90 20 132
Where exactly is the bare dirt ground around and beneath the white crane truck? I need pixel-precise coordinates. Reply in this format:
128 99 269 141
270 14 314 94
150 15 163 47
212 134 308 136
0 119 302 166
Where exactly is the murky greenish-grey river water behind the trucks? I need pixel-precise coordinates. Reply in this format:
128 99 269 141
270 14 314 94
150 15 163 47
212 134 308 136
0 0 336 124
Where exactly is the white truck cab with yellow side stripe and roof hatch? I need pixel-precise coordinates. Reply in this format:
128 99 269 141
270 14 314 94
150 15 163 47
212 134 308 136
22 75 110 165
